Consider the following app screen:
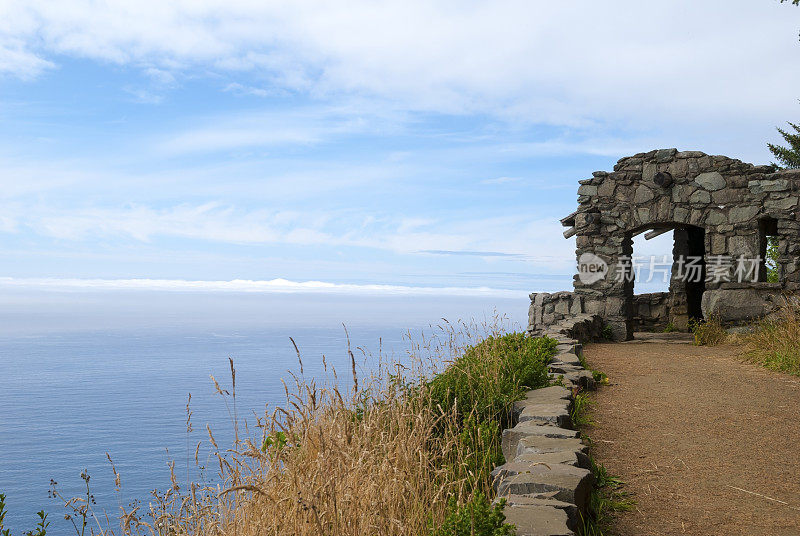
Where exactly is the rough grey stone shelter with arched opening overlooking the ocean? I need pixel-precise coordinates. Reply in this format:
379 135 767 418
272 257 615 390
528 149 800 340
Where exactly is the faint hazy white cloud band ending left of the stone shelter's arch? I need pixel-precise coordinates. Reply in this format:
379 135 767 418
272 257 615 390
0 203 574 270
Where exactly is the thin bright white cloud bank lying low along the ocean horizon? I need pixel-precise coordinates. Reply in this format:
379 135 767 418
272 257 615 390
0 277 527 298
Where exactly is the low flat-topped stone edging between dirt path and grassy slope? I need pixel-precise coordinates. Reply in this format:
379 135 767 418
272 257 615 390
492 319 595 536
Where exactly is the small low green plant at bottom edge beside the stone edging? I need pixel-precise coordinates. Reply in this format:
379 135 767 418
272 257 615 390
430 493 516 536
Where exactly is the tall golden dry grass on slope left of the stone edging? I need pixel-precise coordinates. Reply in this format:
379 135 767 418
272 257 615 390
43 321 549 536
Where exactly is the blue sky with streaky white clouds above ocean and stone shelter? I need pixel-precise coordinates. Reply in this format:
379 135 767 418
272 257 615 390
0 0 800 312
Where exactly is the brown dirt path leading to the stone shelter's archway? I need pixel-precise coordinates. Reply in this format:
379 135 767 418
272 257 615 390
585 341 800 536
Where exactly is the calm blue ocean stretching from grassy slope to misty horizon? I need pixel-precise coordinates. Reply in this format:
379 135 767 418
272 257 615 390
0 295 527 536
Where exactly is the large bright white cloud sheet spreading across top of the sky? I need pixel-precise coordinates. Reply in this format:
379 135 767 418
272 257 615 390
0 0 800 126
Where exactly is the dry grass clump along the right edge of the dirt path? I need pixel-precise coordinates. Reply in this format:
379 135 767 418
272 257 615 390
743 297 800 375
